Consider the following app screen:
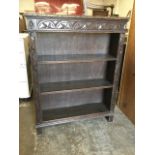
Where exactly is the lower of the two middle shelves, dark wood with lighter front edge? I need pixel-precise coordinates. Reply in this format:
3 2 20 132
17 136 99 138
40 79 113 95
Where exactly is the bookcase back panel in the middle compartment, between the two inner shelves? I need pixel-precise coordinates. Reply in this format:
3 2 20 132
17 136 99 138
38 62 107 83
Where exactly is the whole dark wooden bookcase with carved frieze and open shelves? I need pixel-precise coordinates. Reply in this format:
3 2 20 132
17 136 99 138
25 14 128 133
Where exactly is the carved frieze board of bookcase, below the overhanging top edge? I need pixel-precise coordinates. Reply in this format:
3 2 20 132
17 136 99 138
27 16 126 32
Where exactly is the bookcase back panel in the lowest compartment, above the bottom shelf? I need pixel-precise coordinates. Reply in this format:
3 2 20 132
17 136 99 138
40 90 103 110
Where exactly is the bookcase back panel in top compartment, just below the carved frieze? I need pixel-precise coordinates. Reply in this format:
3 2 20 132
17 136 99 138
36 32 110 55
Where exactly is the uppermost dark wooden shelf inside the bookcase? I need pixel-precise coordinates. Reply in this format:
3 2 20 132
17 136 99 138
38 54 117 64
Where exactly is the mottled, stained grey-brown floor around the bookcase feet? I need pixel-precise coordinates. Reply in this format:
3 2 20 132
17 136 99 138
19 101 135 155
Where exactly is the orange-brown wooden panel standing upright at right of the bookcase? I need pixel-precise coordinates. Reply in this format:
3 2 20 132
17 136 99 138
118 3 135 123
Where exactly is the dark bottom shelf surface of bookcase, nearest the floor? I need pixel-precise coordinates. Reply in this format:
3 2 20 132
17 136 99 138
43 103 107 121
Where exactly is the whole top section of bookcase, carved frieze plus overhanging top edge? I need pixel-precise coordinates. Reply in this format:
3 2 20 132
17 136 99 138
24 13 128 33
